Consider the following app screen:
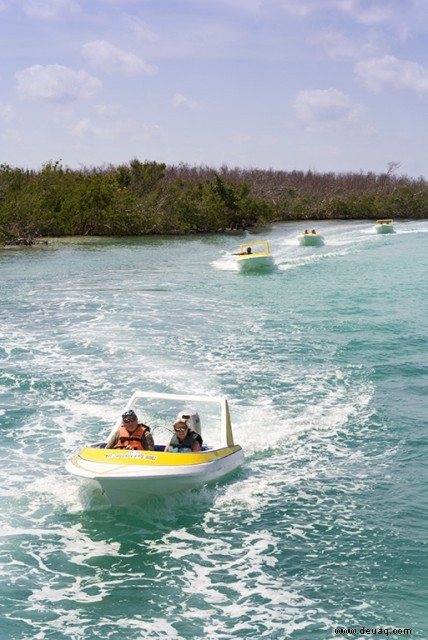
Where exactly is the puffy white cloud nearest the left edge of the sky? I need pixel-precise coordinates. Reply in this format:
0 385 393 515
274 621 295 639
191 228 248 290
15 64 102 102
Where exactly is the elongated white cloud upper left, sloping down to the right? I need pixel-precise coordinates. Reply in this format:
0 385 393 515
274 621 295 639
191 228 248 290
83 40 157 75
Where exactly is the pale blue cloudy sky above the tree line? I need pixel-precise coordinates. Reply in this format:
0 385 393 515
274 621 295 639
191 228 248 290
0 0 428 179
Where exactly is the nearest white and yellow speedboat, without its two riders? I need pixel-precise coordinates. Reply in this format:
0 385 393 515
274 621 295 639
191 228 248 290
66 391 244 506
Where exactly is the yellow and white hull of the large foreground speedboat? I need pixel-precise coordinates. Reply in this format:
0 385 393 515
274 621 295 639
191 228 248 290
66 445 244 506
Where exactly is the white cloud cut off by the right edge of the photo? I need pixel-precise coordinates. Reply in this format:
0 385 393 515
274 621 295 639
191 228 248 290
355 55 428 93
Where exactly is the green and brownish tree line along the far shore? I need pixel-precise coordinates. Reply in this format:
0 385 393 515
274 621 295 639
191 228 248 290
0 159 428 242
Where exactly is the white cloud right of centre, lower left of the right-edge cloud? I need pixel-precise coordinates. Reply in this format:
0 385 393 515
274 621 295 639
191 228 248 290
293 88 365 126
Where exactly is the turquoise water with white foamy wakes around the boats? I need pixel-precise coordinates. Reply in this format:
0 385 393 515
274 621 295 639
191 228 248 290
0 221 428 640
